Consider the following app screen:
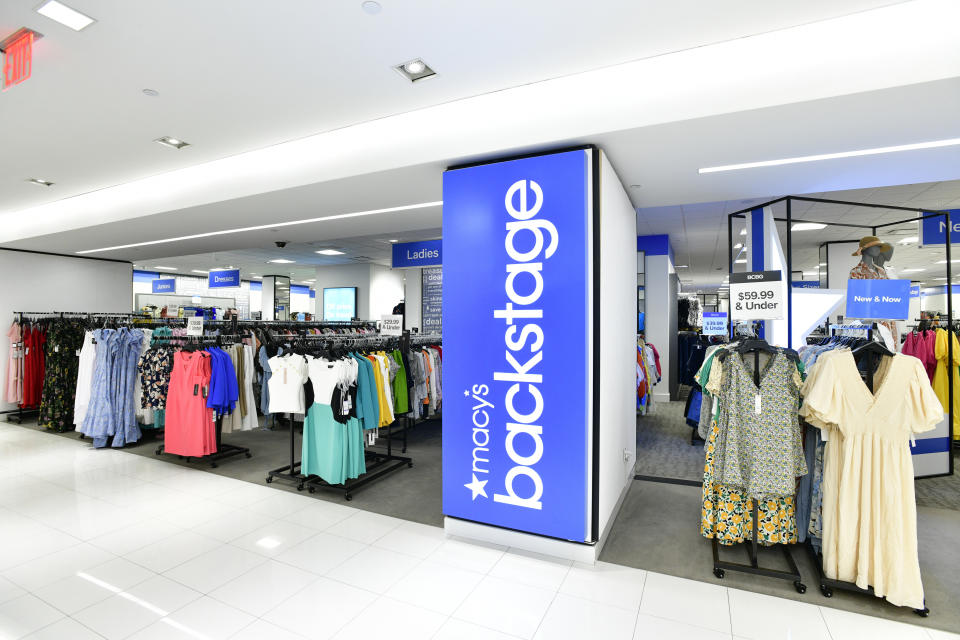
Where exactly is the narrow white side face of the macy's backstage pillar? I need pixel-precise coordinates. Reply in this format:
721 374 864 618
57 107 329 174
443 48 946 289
594 152 632 540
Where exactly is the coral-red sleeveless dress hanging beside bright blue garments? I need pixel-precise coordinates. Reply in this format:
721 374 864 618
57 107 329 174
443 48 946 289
163 351 217 457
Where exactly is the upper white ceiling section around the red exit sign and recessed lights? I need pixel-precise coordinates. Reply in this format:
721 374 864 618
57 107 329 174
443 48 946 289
0 0 897 211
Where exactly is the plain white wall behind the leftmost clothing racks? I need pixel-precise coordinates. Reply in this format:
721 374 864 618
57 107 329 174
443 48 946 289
0 250 133 409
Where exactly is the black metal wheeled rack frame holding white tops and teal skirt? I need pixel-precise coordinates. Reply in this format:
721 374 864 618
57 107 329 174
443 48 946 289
266 334 413 501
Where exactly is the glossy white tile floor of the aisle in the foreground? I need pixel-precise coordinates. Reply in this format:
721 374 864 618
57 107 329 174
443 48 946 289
0 423 960 640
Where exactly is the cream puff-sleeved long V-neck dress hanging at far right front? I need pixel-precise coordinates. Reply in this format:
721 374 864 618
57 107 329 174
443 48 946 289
801 350 943 609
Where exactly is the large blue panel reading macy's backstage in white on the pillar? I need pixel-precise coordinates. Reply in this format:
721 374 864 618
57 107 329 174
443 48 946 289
443 150 592 542
